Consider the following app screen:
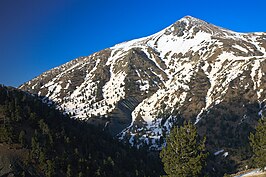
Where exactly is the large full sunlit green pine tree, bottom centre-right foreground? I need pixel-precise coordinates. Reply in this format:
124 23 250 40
160 122 207 177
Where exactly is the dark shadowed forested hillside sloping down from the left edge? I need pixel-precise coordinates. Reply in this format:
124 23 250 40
0 86 162 177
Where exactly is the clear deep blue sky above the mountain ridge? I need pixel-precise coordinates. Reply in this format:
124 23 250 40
0 0 266 86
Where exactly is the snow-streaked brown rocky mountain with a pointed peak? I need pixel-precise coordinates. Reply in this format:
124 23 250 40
19 16 266 173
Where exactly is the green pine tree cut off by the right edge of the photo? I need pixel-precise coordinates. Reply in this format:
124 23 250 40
249 117 266 170
